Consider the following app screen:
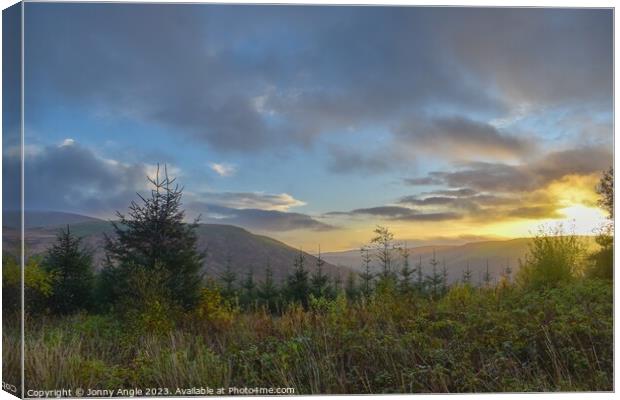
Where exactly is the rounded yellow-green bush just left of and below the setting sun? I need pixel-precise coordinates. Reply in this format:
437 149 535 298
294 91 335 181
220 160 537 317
517 225 585 288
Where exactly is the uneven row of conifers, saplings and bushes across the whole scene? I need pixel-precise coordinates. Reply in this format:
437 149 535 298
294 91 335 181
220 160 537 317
3 168 613 322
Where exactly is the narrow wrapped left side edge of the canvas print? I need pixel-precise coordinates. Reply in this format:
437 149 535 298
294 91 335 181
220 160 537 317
2 3 25 397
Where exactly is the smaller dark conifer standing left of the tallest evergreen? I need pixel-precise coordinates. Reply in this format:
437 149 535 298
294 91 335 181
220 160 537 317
43 225 95 314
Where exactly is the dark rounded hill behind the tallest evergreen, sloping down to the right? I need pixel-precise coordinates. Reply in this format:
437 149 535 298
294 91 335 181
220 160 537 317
3 212 350 281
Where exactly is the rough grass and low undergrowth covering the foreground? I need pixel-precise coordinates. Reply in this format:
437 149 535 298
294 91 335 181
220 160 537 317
3 280 613 394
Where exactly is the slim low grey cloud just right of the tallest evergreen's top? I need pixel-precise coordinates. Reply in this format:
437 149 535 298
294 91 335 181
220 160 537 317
187 202 337 232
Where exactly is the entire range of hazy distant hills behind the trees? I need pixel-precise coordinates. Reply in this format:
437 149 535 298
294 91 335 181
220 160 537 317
3 212 593 283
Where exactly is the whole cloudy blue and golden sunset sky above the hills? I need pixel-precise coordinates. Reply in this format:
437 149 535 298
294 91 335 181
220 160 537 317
4 3 613 250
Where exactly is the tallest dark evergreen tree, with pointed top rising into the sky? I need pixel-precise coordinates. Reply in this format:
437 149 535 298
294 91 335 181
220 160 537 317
103 166 204 309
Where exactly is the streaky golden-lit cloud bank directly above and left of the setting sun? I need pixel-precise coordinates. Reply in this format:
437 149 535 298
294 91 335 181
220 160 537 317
398 147 613 221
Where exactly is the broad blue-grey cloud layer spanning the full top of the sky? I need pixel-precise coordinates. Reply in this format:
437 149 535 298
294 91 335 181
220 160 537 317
26 3 612 154
